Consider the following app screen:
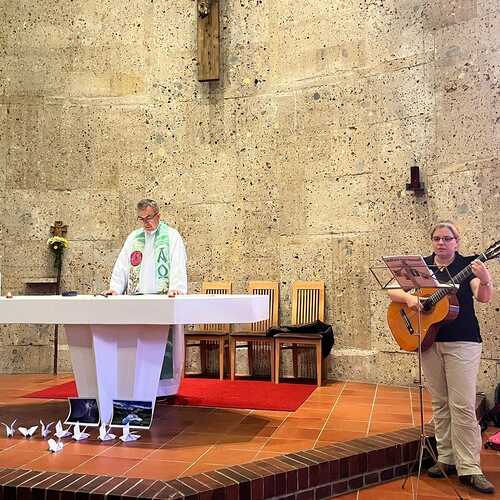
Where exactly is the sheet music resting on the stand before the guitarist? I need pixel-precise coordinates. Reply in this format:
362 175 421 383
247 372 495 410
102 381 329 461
382 255 442 290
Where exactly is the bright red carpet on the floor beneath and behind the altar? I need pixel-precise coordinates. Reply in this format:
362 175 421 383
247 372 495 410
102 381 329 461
24 378 316 411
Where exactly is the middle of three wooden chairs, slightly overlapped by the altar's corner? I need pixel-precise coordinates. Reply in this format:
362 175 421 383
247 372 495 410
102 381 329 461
229 281 280 381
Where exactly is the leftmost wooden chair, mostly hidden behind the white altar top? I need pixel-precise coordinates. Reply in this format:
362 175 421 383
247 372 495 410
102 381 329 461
184 281 232 380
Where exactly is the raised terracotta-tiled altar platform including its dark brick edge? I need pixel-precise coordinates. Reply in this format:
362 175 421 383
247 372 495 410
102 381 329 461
0 375 500 500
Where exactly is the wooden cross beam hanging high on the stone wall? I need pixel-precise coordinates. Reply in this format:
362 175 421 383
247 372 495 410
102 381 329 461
196 0 220 82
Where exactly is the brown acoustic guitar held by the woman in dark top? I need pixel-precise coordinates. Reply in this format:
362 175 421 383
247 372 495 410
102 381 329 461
387 240 500 351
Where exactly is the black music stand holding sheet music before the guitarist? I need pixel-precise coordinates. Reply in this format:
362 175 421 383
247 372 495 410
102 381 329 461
370 255 463 500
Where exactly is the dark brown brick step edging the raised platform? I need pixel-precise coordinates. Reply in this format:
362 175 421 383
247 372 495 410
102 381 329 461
0 425 433 500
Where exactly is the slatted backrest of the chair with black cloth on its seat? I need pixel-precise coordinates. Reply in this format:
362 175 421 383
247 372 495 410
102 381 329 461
292 281 325 325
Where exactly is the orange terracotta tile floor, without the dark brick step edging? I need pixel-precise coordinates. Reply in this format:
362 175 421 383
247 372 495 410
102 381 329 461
0 375 500 500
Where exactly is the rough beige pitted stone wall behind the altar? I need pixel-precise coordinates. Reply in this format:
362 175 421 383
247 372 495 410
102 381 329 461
0 0 500 393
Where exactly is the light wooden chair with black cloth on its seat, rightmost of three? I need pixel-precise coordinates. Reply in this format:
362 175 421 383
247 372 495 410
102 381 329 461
274 281 326 385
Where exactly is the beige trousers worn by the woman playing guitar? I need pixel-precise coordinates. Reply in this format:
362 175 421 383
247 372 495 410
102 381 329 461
422 342 482 476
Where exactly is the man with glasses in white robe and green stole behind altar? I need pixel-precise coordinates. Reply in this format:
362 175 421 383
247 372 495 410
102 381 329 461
103 199 187 396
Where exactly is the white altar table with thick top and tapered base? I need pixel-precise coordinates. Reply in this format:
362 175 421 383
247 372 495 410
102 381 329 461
0 294 269 422
